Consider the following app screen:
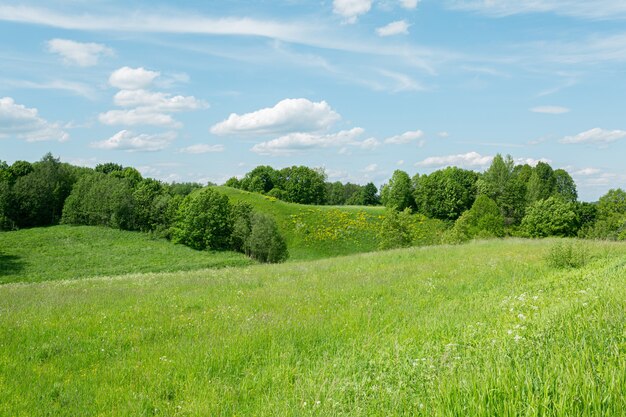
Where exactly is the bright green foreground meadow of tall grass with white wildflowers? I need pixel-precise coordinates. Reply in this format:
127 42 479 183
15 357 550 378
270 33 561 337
0 240 626 417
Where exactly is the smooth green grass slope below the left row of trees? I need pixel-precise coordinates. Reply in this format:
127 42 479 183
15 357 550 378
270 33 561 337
0 226 252 284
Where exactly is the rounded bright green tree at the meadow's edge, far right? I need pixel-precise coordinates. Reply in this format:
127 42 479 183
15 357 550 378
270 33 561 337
522 196 580 237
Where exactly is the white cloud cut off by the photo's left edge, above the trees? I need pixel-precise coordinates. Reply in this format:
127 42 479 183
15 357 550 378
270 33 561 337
0 97 69 142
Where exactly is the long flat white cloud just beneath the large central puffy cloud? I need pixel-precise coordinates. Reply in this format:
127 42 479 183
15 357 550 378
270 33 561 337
250 127 378 156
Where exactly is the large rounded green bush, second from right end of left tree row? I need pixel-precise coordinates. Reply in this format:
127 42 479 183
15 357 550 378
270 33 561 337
172 188 233 250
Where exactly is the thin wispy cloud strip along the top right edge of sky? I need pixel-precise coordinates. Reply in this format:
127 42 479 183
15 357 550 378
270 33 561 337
448 0 626 19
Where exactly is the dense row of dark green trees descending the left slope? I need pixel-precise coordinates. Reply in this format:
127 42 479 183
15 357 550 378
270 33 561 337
0 154 288 262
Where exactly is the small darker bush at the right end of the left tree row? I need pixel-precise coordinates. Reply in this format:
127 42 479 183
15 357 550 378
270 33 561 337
245 213 289 263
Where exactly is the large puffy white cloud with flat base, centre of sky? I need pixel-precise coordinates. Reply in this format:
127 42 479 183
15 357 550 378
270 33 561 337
211 98 341 135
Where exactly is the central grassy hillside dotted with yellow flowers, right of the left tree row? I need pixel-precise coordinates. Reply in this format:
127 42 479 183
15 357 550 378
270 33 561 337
215 187 384 260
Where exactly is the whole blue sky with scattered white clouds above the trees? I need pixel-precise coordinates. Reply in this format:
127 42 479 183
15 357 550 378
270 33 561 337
0 0 626 201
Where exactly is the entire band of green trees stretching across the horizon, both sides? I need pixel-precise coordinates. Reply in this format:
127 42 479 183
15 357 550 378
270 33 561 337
0 154 626 252
